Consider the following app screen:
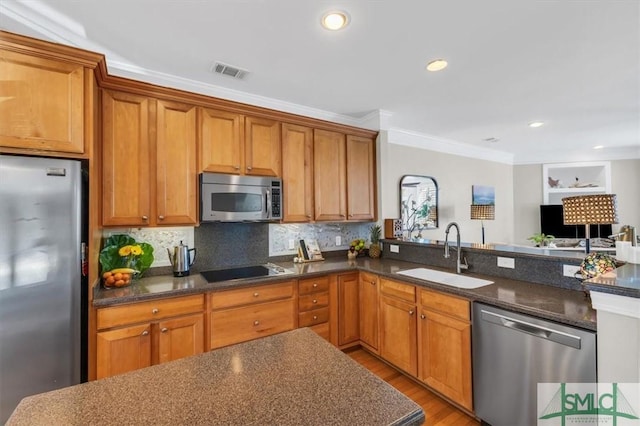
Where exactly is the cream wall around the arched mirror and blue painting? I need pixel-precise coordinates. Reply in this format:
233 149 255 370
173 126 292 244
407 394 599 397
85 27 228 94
378 131 514 243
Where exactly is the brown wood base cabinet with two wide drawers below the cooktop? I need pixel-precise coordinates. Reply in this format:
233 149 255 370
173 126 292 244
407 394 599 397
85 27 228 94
209 281 297 349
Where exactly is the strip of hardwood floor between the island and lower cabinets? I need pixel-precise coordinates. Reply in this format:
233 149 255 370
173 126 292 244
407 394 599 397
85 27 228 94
346 348 480 426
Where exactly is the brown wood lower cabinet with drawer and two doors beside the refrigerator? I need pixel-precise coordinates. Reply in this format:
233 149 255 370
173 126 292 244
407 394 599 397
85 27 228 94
96 295 204 379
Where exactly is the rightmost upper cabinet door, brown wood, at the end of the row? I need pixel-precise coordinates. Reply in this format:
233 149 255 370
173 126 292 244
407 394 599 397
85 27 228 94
347 136 376 220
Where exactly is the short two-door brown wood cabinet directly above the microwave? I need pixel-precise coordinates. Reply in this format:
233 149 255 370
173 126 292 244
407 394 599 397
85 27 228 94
198 108 282 176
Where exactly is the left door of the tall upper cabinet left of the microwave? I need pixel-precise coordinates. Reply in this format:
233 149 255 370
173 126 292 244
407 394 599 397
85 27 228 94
102 90 152 225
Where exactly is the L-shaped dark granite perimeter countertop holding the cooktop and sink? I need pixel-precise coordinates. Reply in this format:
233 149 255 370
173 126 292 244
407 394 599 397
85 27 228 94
93 258 596 330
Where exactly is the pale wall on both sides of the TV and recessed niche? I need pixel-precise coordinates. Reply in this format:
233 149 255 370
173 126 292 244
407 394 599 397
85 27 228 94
513 159 640 244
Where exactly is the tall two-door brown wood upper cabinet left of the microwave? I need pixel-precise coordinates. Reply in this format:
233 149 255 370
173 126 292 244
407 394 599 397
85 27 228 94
102 90 197 226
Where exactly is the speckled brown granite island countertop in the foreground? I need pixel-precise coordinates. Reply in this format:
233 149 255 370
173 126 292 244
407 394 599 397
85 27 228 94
7 328 424 426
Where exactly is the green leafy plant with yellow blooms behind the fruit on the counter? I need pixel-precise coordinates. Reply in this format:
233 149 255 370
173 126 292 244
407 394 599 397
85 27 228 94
100 234 153 276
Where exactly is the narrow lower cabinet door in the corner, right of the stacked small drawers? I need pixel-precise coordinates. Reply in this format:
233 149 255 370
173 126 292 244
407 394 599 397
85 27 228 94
338 273 360 346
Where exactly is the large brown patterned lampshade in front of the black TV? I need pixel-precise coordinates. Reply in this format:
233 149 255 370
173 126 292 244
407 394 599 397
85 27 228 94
562 194 618 225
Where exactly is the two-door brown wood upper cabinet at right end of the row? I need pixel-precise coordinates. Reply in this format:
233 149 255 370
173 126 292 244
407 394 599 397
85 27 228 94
313 130 376 221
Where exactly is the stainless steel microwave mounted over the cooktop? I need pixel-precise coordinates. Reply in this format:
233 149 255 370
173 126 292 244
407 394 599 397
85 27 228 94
200 173 282 222
